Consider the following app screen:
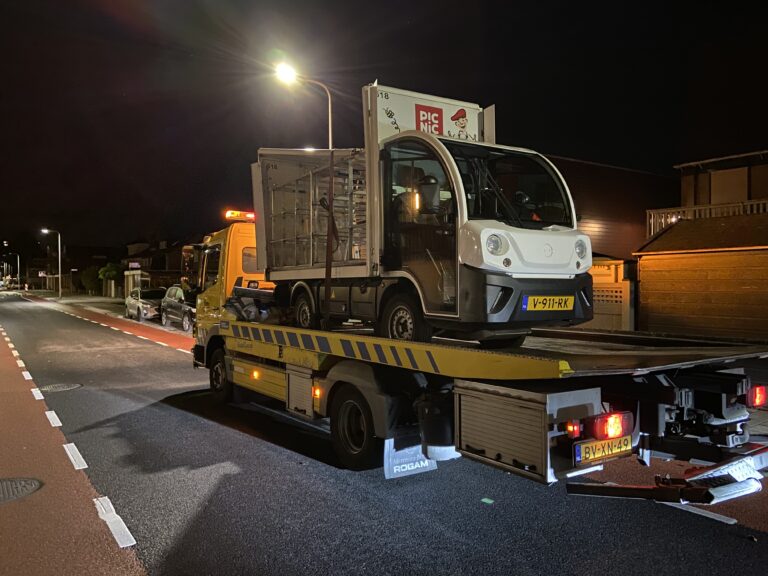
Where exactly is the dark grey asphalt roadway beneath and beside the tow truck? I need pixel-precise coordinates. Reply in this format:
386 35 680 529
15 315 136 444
0 296 768 576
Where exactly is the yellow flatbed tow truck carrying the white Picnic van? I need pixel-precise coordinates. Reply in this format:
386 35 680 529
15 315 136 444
193 214 768 504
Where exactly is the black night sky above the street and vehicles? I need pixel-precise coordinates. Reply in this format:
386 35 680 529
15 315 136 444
0 0 768 250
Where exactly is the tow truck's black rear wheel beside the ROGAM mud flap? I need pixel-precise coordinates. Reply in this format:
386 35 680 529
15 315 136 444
331 384 383 470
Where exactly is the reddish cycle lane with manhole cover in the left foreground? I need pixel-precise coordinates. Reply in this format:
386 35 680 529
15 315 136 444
0 326 144 576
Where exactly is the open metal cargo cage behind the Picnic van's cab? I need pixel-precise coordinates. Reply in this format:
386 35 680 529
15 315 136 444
254 149 368 273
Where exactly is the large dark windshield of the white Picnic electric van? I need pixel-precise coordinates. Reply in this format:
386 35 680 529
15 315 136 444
442 140 573 229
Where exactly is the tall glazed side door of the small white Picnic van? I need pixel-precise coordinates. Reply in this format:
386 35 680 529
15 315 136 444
381 137 458 315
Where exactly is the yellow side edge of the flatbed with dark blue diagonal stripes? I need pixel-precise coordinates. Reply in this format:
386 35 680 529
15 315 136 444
220 322 573 380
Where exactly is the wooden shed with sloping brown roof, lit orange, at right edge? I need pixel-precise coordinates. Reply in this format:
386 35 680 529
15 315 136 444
635 214 768 341
